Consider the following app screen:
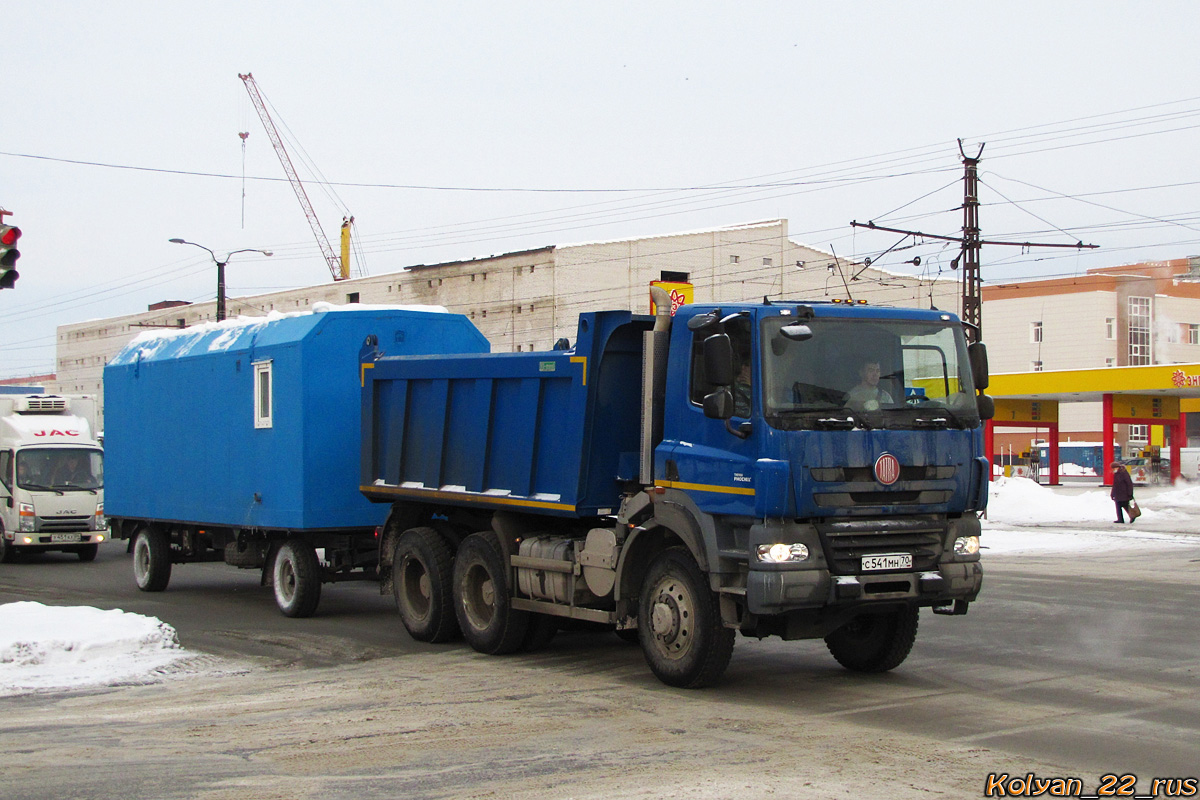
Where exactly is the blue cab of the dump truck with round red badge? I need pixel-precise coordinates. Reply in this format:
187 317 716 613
654 303 991 638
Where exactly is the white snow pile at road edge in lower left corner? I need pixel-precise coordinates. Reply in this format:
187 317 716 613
0 602 190 697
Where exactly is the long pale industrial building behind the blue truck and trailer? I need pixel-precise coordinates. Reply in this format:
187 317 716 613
46 219 960 424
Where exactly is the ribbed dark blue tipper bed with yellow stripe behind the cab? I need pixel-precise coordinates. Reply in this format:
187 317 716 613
361 312 653 517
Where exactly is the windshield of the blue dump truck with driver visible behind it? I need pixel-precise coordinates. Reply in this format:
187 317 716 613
762 317 979 431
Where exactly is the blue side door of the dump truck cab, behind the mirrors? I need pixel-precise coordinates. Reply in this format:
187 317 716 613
655 317 764 515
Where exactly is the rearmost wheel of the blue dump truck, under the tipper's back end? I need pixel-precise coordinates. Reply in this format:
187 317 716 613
391 528 458 642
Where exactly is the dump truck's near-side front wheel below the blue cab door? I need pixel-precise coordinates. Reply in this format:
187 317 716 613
637 547 734 688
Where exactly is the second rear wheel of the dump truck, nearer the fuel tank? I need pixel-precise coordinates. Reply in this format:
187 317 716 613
454 530 529 656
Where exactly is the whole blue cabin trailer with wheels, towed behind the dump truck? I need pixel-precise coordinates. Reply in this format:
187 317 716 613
104 303 490 616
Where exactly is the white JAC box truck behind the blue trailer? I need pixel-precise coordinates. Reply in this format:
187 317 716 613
0 395 108 561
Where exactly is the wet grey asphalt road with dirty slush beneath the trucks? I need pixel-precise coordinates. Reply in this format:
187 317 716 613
0 541 1200 800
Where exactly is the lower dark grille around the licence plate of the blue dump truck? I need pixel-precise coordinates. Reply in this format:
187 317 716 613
817 518 946 575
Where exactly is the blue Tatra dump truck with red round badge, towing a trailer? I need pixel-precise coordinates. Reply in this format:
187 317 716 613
362 293 994 687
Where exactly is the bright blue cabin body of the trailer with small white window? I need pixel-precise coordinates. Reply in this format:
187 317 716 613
104 308 488 530
